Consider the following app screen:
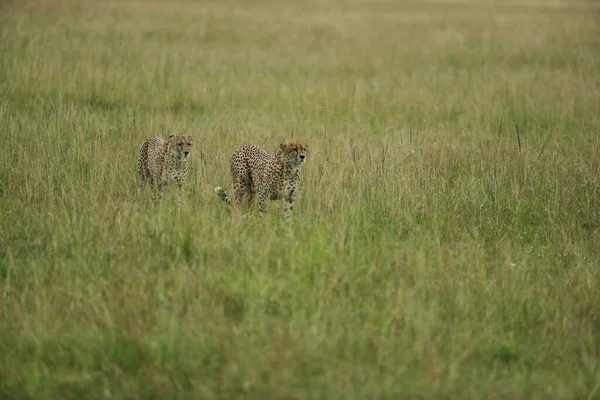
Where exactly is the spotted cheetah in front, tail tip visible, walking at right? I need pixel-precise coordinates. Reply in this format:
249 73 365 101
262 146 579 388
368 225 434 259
215 142 308 220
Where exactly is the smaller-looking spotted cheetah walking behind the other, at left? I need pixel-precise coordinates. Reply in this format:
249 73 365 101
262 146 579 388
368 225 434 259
138 134 192 199
